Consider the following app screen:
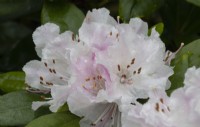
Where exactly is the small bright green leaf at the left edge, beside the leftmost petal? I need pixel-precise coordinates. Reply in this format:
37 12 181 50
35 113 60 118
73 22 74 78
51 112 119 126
0 72 27 92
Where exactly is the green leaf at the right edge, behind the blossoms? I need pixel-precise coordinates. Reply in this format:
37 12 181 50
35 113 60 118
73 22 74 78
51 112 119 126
167 39 200 94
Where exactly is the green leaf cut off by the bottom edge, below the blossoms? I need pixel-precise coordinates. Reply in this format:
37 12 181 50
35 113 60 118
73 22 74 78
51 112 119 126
26 111 80 127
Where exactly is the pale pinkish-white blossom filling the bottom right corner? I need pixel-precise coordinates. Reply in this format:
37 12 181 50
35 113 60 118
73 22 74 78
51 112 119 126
122 67 200 127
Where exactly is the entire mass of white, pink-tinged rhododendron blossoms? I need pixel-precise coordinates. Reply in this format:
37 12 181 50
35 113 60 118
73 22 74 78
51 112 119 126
23 8 200 127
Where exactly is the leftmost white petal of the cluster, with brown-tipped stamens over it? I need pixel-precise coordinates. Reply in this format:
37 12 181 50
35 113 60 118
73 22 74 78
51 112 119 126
23 60 68 90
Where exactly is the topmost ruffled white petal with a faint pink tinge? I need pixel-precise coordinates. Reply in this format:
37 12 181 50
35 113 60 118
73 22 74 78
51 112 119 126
79 8 117 51
